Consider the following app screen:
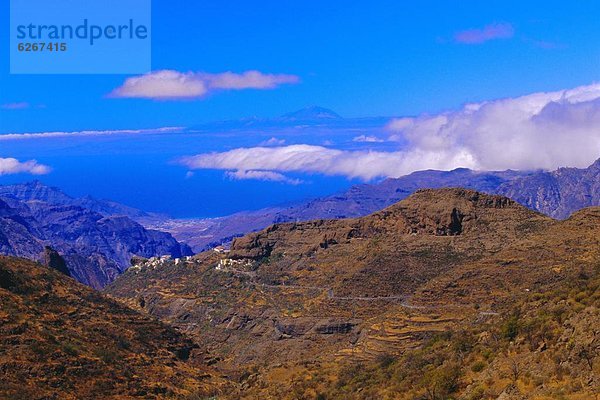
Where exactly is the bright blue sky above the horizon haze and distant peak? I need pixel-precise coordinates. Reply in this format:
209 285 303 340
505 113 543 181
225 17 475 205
0 0 600 132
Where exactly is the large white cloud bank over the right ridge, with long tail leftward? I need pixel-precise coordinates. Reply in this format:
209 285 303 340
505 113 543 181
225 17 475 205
180 84 600 184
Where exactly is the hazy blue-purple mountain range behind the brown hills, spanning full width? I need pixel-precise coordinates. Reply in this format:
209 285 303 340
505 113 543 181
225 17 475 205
0 158 600 288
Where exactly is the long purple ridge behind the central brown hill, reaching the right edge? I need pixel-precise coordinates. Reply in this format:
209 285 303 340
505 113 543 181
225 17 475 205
155 160 600 251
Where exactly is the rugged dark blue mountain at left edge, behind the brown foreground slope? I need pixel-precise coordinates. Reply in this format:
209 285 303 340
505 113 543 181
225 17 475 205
0 191 191 288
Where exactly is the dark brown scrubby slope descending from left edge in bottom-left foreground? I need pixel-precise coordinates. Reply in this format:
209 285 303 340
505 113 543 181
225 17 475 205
0 257 227 400
